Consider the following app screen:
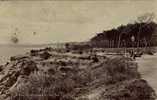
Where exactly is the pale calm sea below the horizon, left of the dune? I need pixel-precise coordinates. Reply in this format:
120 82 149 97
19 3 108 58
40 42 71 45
0 44 63 65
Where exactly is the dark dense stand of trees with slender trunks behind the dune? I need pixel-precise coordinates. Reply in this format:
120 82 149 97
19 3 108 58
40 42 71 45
91 22 157 47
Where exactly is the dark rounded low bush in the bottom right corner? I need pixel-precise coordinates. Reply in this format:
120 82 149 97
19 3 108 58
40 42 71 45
100 79 156 100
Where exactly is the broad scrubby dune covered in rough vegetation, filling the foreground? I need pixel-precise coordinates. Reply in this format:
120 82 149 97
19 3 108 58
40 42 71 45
0 50 155 100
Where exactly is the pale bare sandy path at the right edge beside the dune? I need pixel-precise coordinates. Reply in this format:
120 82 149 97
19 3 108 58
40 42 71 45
136 54 157 93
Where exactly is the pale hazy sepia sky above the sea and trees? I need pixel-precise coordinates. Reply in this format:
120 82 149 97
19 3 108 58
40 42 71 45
0 0 157 44
